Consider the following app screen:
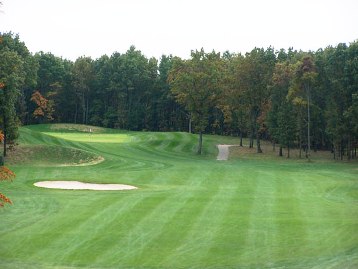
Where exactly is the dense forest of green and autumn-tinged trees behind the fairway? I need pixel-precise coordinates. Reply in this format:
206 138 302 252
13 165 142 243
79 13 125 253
0 33 358 159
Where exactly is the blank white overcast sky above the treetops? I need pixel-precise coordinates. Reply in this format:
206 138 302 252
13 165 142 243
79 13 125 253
0 0 358 60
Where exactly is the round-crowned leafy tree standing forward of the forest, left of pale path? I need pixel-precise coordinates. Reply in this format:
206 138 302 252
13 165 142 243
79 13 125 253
169 49 223 154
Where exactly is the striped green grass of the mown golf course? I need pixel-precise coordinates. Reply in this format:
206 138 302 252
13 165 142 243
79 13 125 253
0 125 358 269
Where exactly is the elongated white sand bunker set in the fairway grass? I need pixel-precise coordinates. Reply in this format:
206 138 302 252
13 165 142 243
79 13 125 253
34 181 137 191
